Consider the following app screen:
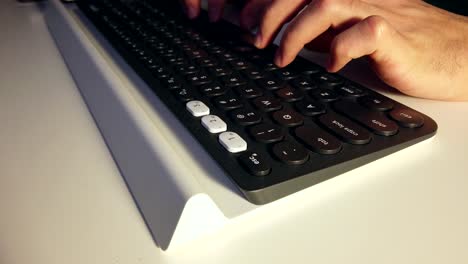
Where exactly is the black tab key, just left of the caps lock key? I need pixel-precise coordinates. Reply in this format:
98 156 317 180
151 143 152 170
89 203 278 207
294 125 342 155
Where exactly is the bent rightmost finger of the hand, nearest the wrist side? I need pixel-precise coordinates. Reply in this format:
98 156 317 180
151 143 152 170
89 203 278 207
327 16 399 72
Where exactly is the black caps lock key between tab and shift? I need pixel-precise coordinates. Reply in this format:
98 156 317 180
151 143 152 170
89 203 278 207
319 112 372 145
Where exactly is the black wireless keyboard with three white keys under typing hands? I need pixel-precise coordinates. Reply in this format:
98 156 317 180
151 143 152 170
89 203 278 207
78 0 437 204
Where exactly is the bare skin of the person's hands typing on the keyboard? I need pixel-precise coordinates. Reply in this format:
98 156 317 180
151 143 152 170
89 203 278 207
184 0 468 101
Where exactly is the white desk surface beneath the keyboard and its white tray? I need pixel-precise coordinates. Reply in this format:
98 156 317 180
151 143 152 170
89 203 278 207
0 1 468 264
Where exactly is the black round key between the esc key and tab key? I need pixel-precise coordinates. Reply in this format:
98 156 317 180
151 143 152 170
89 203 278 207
273 141 309 165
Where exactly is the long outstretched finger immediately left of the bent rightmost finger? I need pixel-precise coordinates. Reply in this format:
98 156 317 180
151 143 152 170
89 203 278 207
275 0 370 67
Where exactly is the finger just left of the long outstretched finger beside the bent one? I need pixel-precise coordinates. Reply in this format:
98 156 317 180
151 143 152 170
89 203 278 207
255 0 309 48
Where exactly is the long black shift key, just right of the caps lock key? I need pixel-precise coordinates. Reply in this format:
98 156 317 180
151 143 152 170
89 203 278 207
333 101 398 136
